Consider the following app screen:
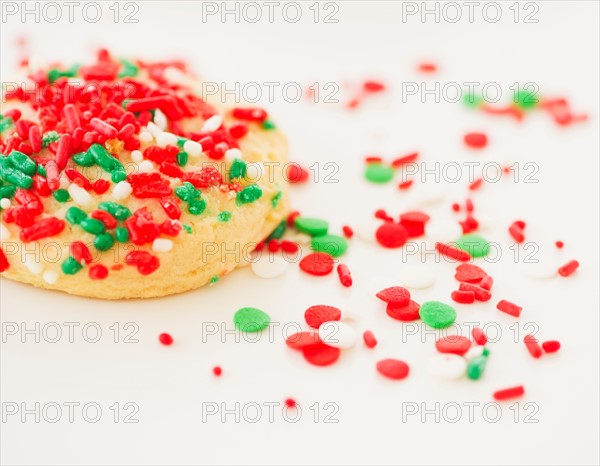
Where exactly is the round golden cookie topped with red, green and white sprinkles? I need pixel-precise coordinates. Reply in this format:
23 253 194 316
0 50 288 299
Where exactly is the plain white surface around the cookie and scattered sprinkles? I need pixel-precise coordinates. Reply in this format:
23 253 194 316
0 2 599 464
